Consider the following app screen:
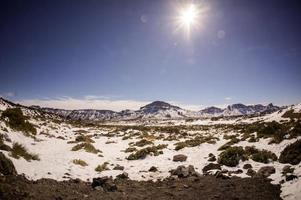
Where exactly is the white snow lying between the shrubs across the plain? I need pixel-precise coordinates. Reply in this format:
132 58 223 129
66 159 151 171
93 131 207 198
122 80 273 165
0 104 301 200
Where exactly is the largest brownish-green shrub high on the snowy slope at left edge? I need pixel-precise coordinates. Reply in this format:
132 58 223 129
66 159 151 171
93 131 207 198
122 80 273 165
1 108 37 135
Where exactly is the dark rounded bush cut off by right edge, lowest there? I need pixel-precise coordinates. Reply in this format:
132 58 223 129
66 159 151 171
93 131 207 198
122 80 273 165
279 140 301 165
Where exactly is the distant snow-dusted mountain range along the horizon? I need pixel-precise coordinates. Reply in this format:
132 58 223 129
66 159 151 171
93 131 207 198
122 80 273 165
0 98 280 121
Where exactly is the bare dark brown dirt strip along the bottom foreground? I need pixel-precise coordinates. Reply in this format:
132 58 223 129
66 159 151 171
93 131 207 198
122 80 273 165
0 175 281 200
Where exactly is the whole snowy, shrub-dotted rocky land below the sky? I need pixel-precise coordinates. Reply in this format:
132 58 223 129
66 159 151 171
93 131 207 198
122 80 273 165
0 99 301 200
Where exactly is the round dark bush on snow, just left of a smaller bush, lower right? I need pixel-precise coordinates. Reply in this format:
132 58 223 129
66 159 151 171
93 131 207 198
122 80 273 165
218 147 246 167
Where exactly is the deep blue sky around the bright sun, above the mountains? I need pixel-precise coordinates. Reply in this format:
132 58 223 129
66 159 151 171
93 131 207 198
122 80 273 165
0 0 301 110
